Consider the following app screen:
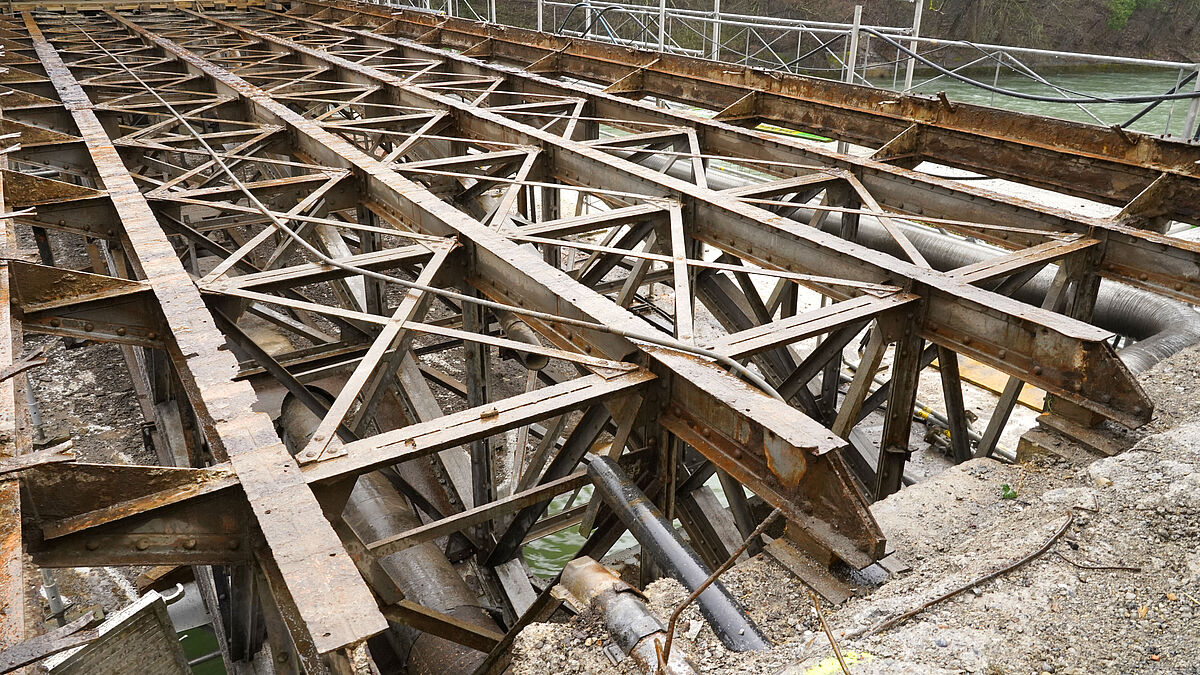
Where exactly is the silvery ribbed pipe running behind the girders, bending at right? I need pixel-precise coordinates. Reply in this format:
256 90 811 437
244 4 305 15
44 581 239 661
618 153 1200 375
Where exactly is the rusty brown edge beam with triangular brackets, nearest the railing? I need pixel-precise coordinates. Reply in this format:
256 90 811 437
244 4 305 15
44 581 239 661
331 1 1200 222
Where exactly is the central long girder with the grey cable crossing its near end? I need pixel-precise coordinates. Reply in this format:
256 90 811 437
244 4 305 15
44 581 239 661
98 7 882 557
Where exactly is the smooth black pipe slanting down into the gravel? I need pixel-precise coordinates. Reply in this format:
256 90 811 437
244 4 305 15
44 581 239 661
586 455 770 651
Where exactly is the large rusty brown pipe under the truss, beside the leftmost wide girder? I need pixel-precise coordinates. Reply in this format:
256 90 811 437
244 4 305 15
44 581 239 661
280 390 499 675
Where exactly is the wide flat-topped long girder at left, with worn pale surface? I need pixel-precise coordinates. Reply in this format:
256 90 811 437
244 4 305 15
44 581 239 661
24 14 386 667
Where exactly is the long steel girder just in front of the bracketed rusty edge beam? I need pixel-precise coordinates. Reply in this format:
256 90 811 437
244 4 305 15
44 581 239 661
292 0 1200 304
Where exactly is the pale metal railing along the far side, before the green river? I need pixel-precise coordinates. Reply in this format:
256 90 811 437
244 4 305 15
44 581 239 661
369 0 1200 139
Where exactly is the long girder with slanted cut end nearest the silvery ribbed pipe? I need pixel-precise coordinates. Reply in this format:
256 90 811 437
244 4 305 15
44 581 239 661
180 6 1151 426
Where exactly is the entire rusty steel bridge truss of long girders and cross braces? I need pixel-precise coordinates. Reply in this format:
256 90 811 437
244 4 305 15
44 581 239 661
0 2 1185 671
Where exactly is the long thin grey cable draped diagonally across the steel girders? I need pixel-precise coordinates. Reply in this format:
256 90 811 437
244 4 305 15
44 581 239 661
68 22 786 402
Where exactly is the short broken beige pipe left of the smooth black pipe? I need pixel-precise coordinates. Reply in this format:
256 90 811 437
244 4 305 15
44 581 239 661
559 556 696 675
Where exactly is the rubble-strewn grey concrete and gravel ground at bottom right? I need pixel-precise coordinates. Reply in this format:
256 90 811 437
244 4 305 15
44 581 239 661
512 348 1200 675
